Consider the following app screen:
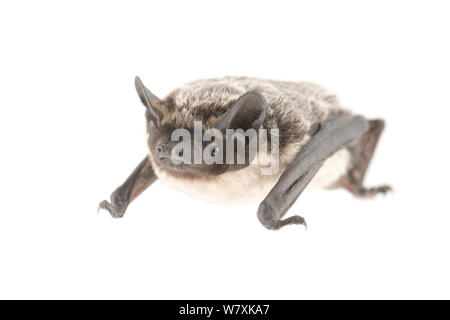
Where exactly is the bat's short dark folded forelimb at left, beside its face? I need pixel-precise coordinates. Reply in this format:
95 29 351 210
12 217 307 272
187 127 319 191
98 156 157 218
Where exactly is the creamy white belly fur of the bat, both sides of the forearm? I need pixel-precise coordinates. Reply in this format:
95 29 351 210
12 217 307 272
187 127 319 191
155 149 351 204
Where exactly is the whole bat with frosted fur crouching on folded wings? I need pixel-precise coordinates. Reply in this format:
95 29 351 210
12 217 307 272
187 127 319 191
99 77 391 230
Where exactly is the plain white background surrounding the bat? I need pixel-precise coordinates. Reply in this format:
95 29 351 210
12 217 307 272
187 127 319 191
0 1 450 299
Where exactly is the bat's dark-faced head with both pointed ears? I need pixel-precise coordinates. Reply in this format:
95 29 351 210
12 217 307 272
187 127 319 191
136 77 267 179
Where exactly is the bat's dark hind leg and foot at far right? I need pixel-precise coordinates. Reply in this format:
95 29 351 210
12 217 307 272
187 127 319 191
338 119 392 197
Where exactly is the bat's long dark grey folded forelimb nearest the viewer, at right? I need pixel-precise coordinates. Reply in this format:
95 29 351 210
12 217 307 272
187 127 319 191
258 115 369 229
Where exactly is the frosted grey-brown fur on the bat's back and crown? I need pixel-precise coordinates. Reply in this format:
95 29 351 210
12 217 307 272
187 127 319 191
159 77 346 152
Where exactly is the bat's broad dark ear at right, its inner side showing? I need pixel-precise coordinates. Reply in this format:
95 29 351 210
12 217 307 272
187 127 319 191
215 91 267 130
